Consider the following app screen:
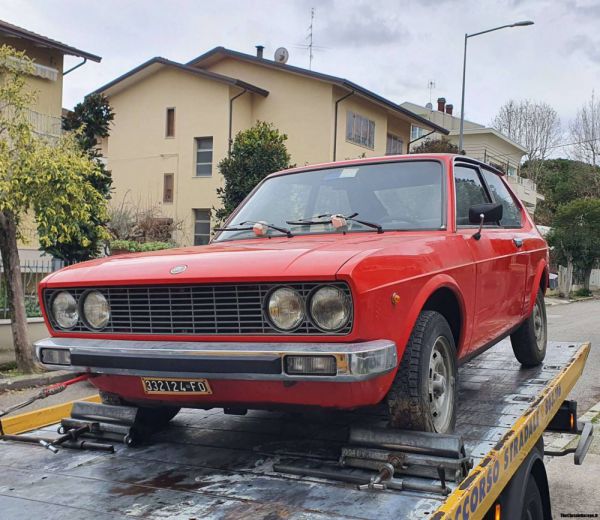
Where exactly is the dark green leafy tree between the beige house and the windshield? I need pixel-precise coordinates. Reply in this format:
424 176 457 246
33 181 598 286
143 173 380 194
215 121 291 222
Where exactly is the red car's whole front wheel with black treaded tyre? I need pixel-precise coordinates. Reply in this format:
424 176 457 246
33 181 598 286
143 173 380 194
387 311 458 433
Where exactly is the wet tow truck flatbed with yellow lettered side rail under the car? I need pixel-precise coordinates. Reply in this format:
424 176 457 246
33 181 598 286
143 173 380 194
0 341 590 520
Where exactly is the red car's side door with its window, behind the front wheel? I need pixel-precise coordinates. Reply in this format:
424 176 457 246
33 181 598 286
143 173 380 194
454 164 527 352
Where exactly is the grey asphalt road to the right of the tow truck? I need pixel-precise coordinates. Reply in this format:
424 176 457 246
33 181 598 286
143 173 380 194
546 300 600 412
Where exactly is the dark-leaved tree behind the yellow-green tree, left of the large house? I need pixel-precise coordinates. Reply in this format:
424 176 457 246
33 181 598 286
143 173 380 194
43 94 115 264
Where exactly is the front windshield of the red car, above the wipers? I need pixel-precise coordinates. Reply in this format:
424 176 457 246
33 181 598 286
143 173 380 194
216 160 443 241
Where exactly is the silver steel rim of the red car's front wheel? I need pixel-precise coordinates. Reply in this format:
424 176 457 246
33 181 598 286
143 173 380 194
429 336 454 432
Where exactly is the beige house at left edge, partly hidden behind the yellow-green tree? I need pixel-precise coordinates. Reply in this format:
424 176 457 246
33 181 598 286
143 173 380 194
0 20 102 262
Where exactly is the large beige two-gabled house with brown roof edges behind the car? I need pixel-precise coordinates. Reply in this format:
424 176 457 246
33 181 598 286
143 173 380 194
96 46 448 245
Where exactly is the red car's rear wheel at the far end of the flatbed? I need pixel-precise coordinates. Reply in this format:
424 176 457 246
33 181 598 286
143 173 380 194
510 289 548 367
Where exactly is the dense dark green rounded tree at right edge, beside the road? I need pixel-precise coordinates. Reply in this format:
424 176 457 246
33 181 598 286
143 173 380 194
547 198 600 296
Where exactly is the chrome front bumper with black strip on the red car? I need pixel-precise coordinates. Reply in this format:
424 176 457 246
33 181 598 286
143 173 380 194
35 338 398 382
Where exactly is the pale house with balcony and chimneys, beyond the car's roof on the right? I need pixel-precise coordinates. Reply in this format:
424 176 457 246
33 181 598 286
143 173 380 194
402 98 544 215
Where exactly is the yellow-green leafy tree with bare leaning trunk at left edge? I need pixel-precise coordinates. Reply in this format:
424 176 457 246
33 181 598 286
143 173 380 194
0 45 106 373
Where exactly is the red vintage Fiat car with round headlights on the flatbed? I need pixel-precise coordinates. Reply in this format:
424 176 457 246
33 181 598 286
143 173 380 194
36 154 548 432
